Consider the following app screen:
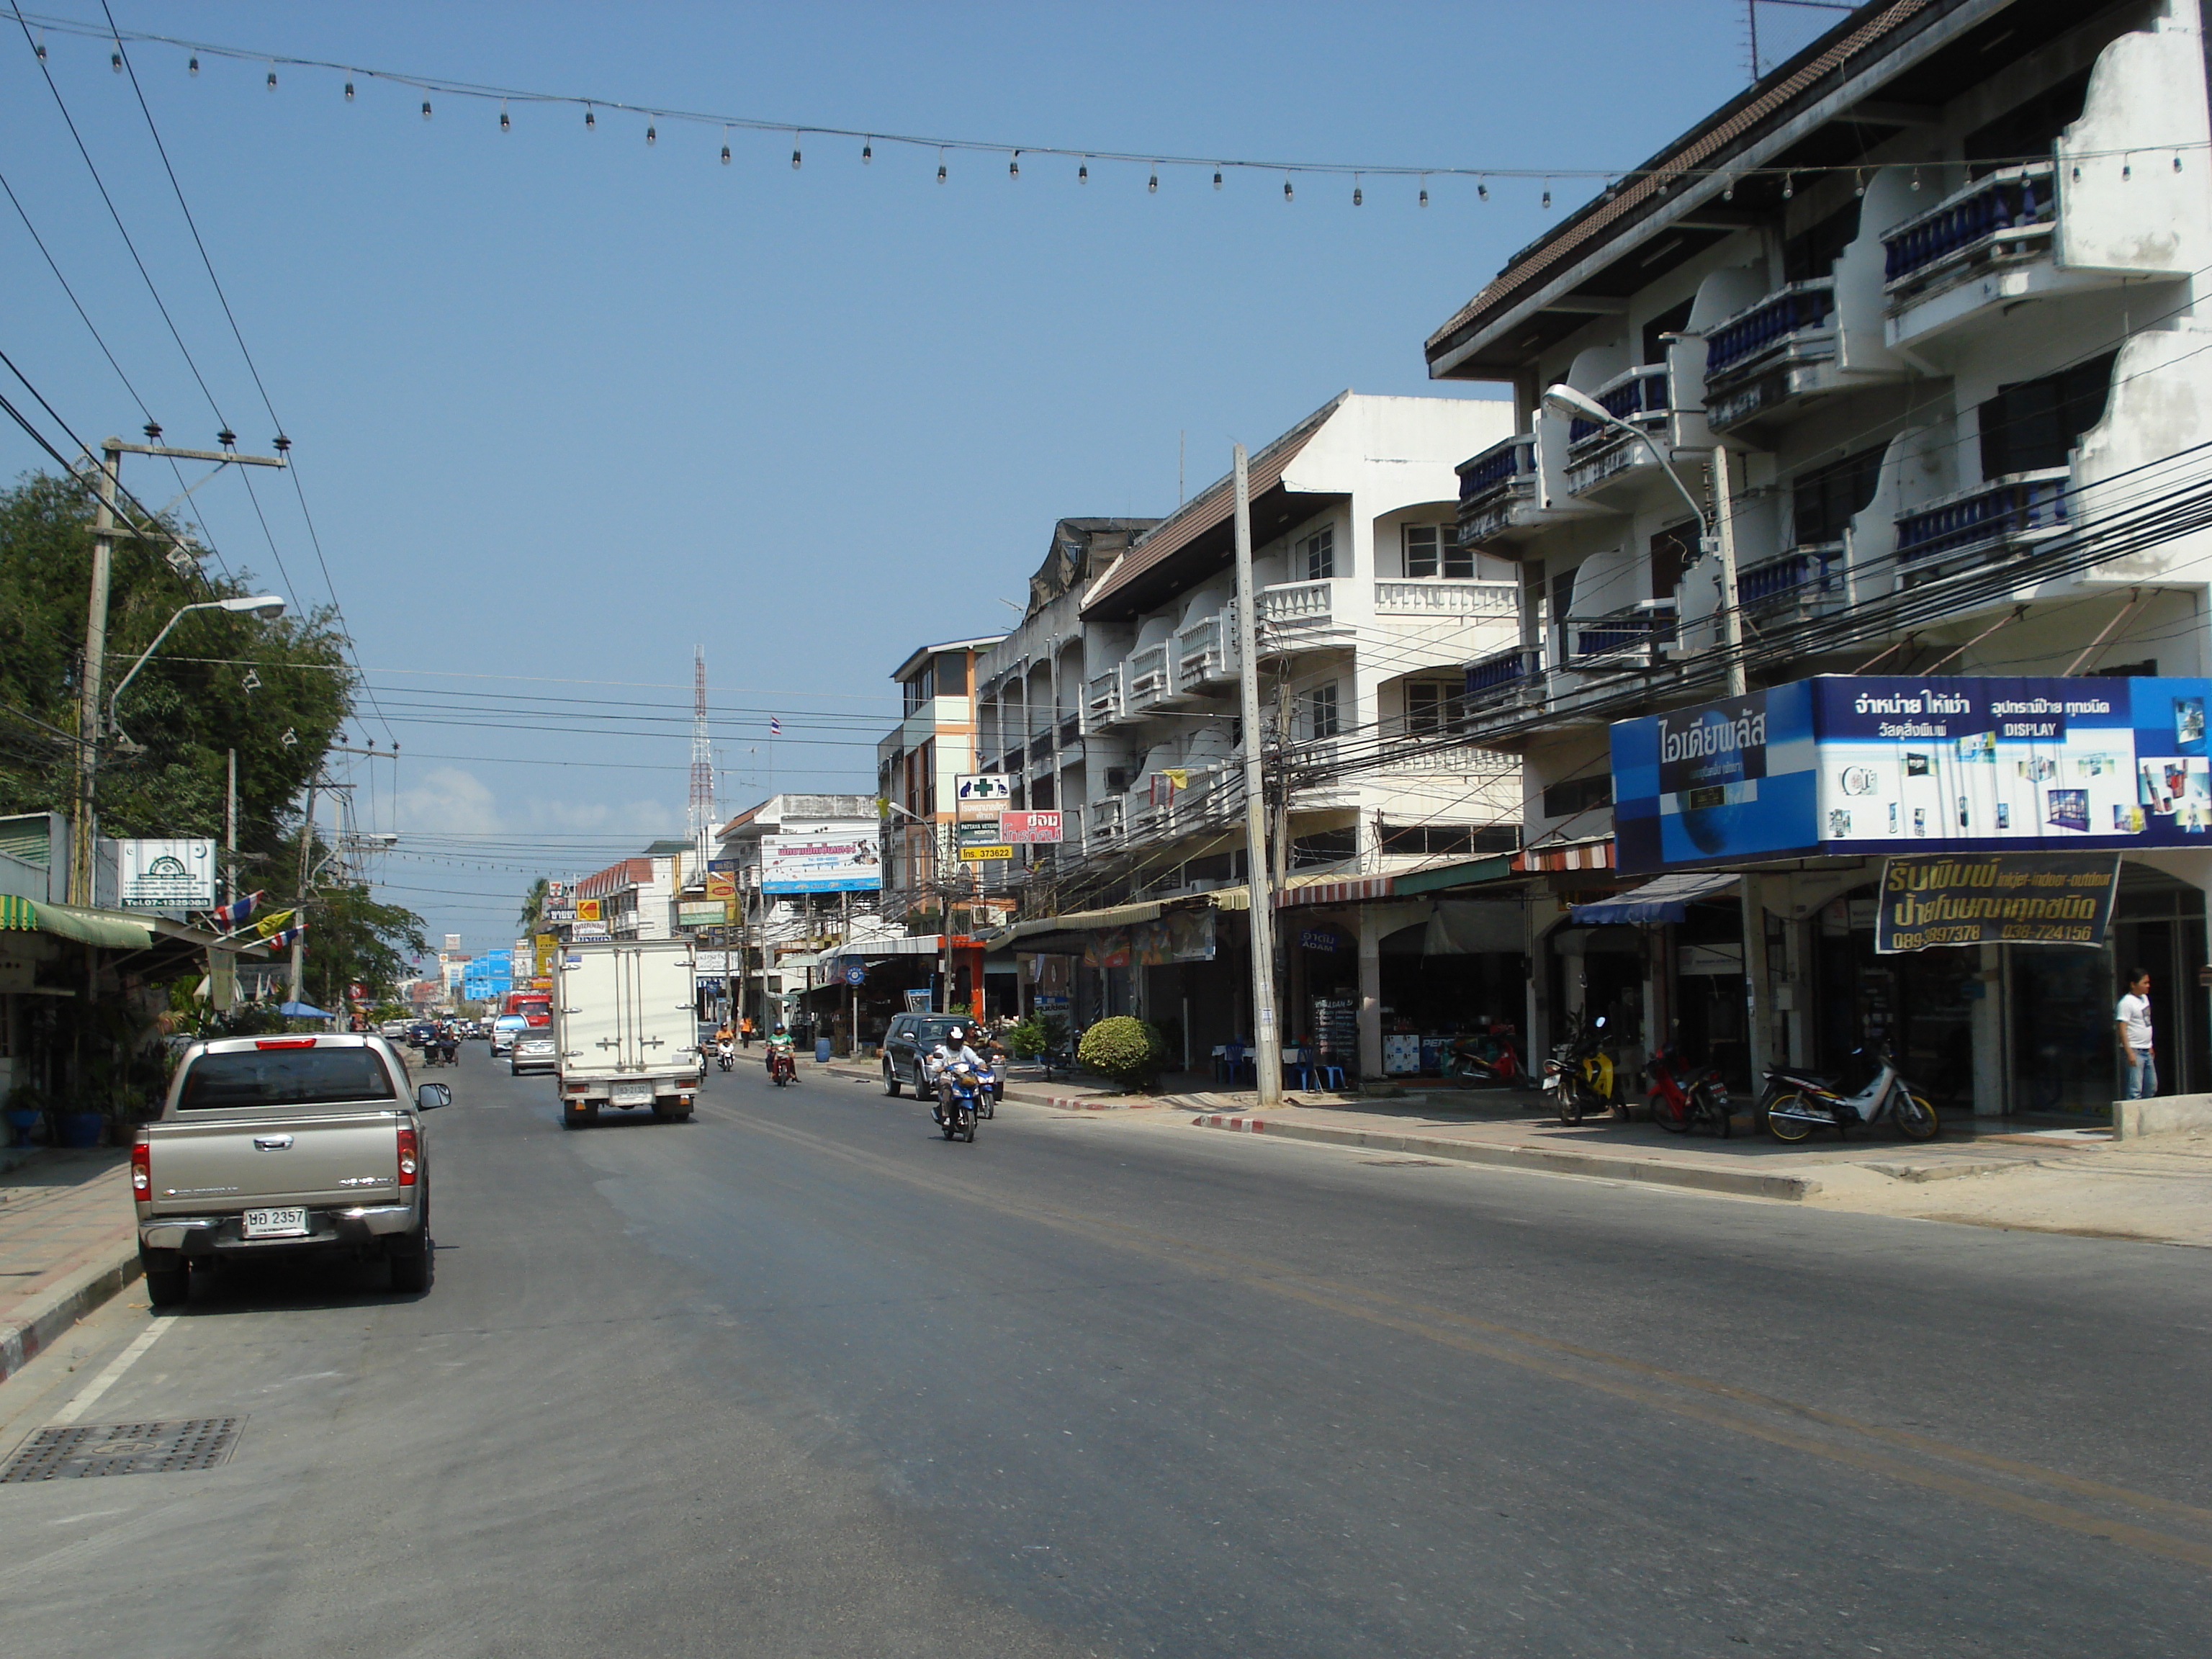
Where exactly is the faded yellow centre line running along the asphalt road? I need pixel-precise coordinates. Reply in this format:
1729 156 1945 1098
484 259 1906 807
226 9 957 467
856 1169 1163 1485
712 1112 2212 1568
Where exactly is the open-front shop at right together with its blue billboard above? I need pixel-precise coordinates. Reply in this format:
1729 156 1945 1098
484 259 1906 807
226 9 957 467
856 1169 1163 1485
1610 677 2212 1117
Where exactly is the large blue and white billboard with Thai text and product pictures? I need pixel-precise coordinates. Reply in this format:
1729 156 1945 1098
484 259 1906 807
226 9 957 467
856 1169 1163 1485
1612 675 2212 871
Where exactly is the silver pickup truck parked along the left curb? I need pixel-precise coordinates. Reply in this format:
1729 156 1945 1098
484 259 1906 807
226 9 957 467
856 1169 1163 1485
130 1035 454 1308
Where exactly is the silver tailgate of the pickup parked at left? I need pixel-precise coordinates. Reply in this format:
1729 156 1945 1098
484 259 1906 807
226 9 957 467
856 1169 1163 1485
146 1110 400 1215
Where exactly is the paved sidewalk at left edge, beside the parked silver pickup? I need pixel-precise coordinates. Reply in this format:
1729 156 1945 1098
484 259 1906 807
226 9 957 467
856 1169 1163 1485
0 1146 140 1380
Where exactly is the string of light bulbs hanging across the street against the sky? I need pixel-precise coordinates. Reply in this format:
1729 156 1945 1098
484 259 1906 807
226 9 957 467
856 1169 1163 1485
13 6 2212 210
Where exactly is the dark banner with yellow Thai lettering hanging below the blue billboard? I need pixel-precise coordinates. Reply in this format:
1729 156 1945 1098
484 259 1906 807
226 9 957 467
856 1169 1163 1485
1874 852 2119 956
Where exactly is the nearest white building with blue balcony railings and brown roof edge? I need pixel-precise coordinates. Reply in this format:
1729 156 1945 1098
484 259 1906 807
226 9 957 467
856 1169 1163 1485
1429 0 2212 1110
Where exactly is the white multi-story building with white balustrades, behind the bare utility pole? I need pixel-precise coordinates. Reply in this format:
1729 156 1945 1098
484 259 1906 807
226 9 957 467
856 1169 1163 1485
976 392 1519 1073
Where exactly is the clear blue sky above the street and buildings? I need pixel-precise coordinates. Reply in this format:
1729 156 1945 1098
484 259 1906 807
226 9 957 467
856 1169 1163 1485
0 0 1836 947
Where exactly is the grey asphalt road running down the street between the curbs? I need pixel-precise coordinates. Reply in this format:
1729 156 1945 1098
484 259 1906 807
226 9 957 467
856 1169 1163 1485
0 1046 2212 1659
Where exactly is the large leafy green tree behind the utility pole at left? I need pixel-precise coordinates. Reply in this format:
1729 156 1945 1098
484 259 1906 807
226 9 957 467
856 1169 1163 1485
0 473 354 885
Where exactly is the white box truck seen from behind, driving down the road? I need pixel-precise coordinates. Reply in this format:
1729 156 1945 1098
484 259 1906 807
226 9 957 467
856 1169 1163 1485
553 938 699 1128
